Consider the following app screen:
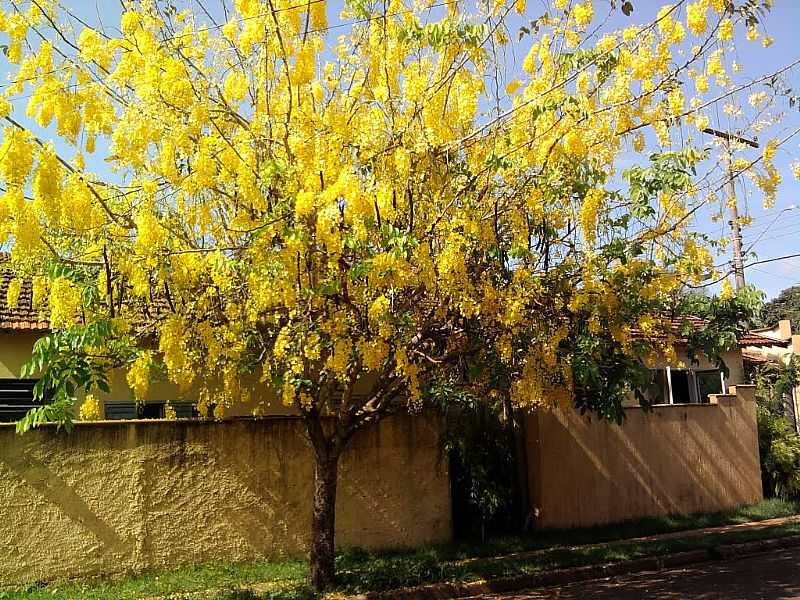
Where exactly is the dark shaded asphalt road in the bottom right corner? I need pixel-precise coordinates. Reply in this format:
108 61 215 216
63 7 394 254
481 548 800 600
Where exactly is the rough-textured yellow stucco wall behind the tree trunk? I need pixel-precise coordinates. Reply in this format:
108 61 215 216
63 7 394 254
0 417 451 583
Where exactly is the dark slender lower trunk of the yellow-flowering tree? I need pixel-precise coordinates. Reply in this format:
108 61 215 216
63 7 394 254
311 453 339 592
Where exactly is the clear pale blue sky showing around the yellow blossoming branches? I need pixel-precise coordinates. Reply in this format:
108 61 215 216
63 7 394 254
0 0 800 298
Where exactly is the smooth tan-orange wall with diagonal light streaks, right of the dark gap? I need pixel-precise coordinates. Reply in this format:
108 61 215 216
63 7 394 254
526 386 762 527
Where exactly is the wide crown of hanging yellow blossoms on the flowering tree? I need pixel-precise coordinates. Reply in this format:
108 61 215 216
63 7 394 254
0 0 792 585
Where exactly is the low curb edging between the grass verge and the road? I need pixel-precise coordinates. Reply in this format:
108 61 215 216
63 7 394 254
351 535 800 600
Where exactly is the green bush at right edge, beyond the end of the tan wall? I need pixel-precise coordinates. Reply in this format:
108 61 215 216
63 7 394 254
753 356 800 498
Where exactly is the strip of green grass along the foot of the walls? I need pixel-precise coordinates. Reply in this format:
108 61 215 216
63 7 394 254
0 499 800 600
